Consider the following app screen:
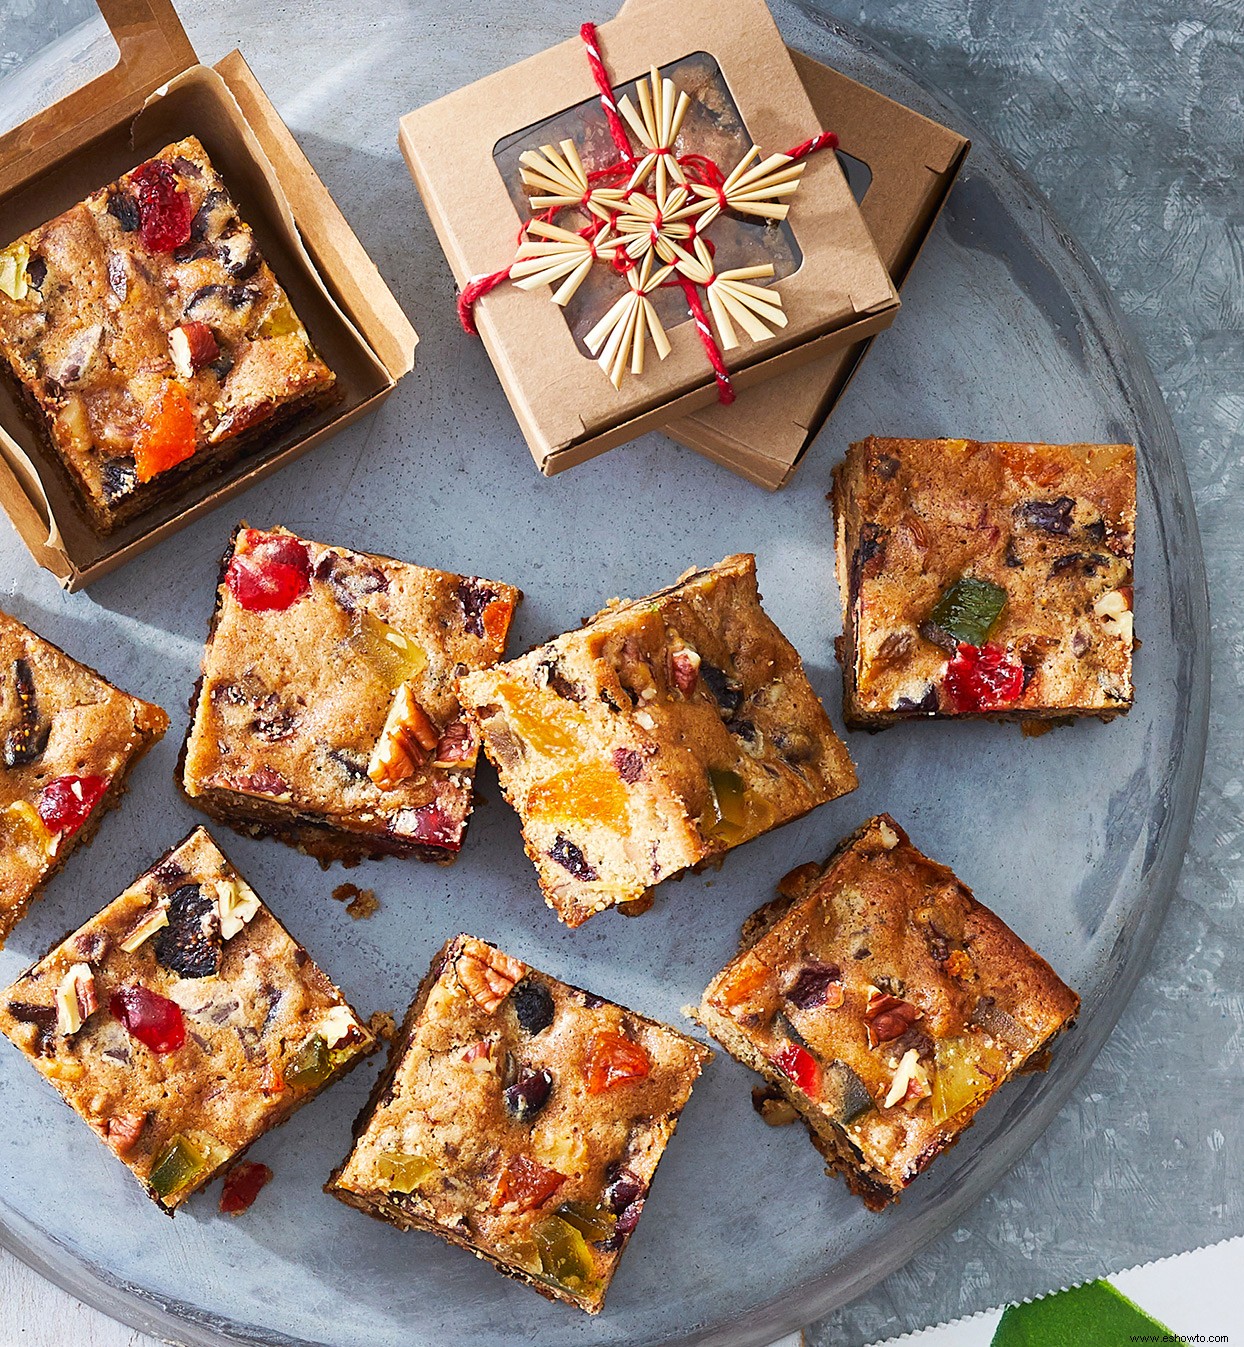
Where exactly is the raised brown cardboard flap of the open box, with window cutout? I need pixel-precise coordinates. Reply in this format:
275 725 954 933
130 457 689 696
0 0 198 197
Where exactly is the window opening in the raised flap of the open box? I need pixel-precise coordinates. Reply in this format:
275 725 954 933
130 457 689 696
0 0 121 138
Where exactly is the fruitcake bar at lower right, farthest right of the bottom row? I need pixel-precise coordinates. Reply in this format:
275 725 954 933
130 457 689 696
695 814 1080 1210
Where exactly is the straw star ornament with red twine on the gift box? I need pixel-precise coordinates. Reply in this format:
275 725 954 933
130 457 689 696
458 24 837 403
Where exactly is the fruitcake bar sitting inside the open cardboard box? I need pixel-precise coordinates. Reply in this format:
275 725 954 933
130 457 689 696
0 136 334 532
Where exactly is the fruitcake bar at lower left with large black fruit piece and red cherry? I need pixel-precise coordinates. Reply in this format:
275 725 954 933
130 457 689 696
0 828 377 1214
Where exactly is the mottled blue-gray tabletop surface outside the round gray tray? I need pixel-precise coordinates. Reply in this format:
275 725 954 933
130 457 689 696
0 0 1244 1347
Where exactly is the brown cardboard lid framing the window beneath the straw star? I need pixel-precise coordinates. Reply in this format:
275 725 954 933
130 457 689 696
401 0 898 470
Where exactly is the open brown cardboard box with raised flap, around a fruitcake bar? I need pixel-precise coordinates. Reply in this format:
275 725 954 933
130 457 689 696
0 0 419 590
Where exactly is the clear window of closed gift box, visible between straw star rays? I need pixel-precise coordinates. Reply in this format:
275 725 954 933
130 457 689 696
493 51 818 356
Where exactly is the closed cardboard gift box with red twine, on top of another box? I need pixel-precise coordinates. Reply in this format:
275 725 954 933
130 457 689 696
400 0 898 474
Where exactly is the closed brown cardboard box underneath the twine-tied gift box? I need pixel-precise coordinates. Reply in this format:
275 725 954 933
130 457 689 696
670 55 971 490
